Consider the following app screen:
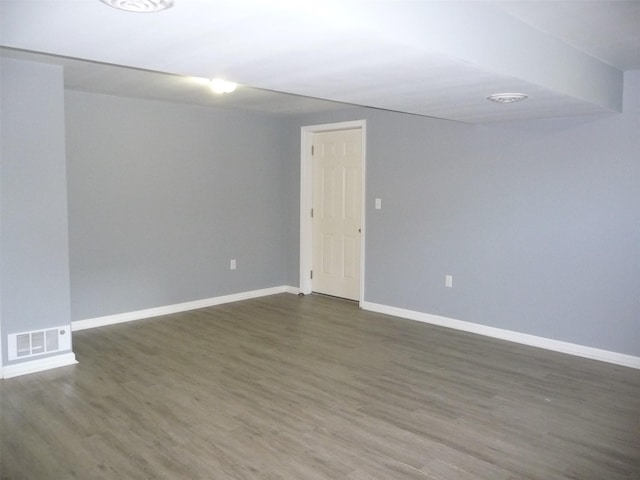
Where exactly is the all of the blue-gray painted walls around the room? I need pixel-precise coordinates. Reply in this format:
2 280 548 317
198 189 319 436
0 57 640 364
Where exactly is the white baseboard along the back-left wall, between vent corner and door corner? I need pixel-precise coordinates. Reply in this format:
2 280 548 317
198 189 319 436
71 286 295 332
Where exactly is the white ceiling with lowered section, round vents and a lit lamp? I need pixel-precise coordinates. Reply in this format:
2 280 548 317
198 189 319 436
0 0 640 123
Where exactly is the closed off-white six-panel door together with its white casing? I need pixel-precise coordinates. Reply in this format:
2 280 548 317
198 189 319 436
300 120 366 301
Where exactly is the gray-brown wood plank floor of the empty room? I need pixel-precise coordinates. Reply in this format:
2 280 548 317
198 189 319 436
0 294 640 480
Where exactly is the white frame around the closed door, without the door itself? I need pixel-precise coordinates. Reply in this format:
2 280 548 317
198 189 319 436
300 120 367 304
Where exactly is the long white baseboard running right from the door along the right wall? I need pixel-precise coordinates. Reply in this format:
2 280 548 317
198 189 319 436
360 302 640 369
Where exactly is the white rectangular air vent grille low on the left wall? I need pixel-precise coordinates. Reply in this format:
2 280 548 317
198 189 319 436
8 325 71 360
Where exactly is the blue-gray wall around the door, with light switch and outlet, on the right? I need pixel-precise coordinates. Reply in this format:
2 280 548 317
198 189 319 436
287 71 640 355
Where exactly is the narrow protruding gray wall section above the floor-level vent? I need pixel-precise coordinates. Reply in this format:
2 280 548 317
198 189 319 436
0 59 70 365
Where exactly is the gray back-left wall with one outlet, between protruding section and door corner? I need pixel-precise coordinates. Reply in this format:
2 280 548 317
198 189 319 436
66 91 288 320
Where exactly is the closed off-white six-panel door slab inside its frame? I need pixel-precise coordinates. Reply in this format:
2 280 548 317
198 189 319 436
312 129 362 300
